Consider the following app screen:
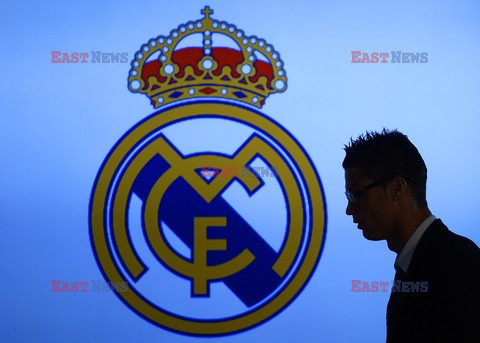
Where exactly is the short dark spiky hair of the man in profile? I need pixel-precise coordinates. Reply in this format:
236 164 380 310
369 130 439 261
342 128 427 206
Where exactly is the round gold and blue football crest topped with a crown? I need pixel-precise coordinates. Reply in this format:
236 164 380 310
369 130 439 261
90 7 326 336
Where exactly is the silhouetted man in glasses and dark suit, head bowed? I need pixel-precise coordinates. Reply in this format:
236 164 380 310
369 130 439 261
343 129 480 342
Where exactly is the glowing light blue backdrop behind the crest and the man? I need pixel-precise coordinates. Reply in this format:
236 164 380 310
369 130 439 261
0 0 480 342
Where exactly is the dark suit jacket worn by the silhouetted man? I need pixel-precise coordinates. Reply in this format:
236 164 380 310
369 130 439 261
387 219 480 343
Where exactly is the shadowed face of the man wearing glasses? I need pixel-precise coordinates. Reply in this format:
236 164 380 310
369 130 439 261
345 167 396 241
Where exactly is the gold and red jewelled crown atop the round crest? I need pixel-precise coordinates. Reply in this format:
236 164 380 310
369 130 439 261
128 6 287 108
